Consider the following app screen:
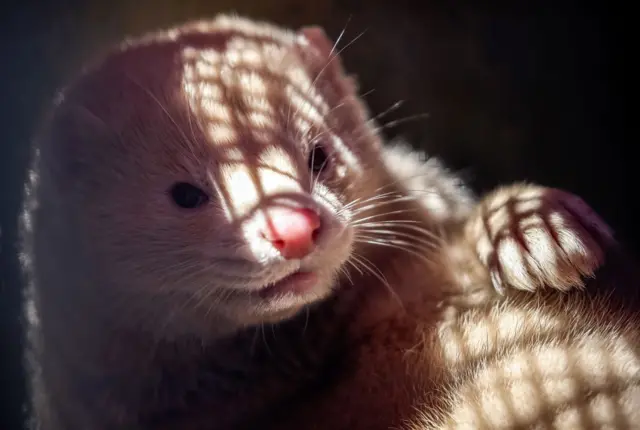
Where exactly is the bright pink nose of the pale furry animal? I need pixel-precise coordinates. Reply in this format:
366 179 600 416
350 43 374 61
262 208 321 260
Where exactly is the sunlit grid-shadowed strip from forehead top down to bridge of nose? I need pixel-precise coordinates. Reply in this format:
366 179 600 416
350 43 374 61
175 18 359 219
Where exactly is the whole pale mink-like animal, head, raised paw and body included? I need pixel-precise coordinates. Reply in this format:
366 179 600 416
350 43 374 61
23 16 640 430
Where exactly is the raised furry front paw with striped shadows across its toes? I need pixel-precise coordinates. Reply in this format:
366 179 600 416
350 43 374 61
468 185 613 293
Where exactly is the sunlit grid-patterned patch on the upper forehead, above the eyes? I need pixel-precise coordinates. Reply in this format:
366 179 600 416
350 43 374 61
182 31 329 151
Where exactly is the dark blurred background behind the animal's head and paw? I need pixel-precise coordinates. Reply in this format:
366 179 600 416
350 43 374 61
0 0 640 430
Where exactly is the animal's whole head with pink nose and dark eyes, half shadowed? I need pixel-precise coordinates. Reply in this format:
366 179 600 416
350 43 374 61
36 16 400 338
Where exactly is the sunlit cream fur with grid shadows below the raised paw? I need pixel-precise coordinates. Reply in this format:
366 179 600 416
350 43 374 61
412 301 640 430
